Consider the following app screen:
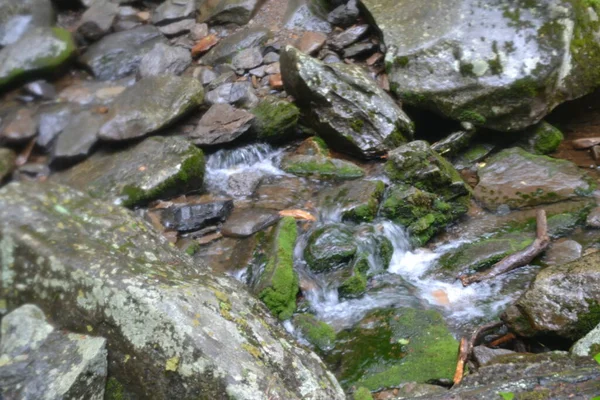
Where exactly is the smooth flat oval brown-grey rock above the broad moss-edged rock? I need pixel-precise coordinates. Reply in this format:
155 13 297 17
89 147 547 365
99 75 204 141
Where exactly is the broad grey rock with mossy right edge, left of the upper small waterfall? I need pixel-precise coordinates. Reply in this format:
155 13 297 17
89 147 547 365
57 137 204 207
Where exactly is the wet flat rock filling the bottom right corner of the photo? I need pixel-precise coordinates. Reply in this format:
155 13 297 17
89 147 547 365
426 352 600 400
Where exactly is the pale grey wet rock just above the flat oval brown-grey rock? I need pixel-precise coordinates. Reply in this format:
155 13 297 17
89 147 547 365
138 43 192 78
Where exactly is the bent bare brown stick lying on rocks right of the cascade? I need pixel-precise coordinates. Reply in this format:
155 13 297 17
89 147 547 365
458 210 550 286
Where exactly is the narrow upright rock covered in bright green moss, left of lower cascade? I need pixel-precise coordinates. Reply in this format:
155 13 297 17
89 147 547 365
253 217 298 321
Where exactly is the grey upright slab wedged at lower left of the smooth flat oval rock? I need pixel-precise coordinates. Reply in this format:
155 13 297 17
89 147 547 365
52 110 106 165
